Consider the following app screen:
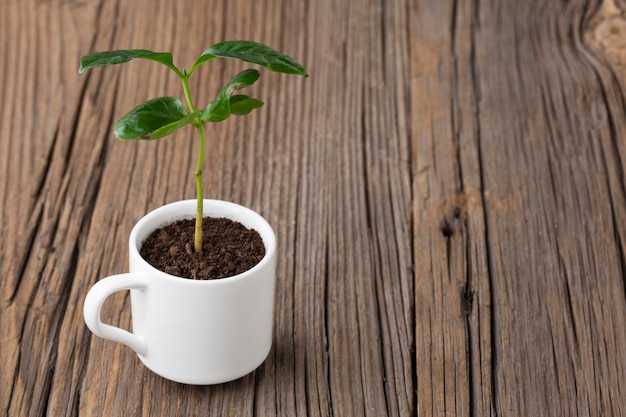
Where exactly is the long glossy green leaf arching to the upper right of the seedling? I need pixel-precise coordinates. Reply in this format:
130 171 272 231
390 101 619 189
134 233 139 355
189 41 307 77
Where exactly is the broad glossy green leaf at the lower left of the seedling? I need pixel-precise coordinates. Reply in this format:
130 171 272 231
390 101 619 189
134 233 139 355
114 97 190 140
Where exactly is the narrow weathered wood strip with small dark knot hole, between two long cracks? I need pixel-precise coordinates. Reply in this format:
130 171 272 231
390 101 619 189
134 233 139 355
411 2 494 416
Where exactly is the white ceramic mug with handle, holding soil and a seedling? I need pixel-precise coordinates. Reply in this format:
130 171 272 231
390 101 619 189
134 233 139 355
84 200 276 385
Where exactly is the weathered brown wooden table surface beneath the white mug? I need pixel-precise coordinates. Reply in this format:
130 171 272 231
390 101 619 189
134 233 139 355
0 0 626 417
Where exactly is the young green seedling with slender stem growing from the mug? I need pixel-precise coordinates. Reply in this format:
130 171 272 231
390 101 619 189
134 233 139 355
78 41 307 252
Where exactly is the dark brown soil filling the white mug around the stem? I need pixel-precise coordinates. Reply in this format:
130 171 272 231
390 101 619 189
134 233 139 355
140 217 265 280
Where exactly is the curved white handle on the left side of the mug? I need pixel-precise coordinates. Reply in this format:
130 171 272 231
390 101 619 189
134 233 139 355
83 273 148 355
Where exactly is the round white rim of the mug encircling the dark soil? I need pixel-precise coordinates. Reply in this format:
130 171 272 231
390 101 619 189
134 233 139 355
129 199 276 286
